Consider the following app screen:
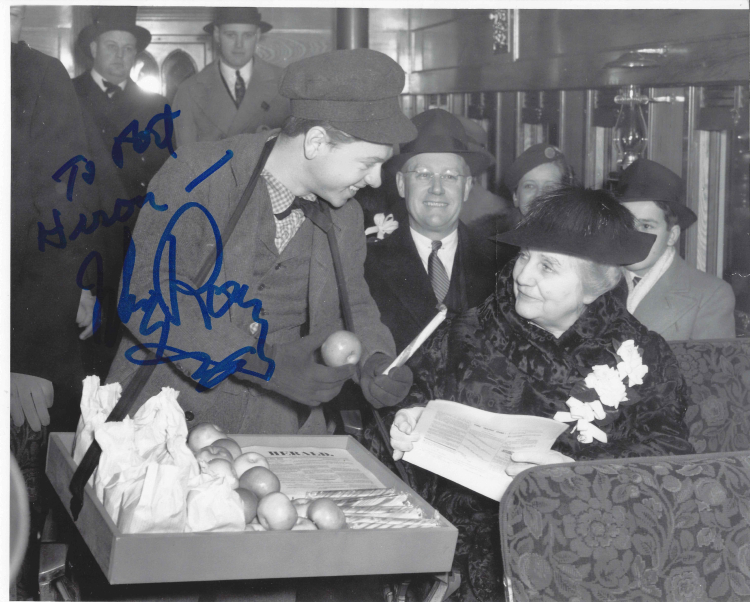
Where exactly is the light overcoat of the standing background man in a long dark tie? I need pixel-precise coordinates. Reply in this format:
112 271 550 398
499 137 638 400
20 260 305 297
174 56 289 146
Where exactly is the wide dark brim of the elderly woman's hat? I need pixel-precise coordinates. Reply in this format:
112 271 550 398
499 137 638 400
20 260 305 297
493 224 656 265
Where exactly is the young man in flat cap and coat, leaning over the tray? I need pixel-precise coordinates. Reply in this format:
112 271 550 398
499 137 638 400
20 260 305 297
107 49 416 434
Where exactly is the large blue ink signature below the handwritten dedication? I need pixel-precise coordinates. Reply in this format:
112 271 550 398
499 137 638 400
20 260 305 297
117 202 275 391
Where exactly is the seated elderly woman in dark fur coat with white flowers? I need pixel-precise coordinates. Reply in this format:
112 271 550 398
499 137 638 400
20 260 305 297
391 188 693 602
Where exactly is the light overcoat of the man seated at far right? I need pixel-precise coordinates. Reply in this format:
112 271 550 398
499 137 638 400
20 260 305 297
633 255 735 341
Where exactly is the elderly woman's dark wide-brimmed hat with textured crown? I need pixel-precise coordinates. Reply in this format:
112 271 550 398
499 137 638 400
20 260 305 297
494 186 656 265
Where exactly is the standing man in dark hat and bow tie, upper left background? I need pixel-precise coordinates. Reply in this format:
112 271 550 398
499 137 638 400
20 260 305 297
73 6 174 378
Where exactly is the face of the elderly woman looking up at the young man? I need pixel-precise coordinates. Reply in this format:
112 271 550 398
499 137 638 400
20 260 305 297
513 249 595 337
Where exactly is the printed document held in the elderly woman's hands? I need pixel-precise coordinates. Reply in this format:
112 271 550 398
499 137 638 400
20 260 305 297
404 399 569 501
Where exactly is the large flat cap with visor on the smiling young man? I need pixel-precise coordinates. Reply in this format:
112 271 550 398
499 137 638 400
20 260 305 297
279 48 417 144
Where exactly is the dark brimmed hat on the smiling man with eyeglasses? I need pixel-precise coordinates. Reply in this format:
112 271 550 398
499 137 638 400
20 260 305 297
385 109 493 176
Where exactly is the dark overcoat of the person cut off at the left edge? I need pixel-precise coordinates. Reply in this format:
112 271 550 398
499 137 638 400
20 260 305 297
8 42 99 430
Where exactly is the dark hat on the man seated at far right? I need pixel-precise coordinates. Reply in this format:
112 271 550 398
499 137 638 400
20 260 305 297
617 159 698 230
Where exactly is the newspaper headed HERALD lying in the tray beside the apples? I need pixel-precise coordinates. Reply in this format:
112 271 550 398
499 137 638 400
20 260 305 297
242 445 385 497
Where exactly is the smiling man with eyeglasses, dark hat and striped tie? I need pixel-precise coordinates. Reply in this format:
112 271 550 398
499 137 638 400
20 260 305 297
365 109 495 352
